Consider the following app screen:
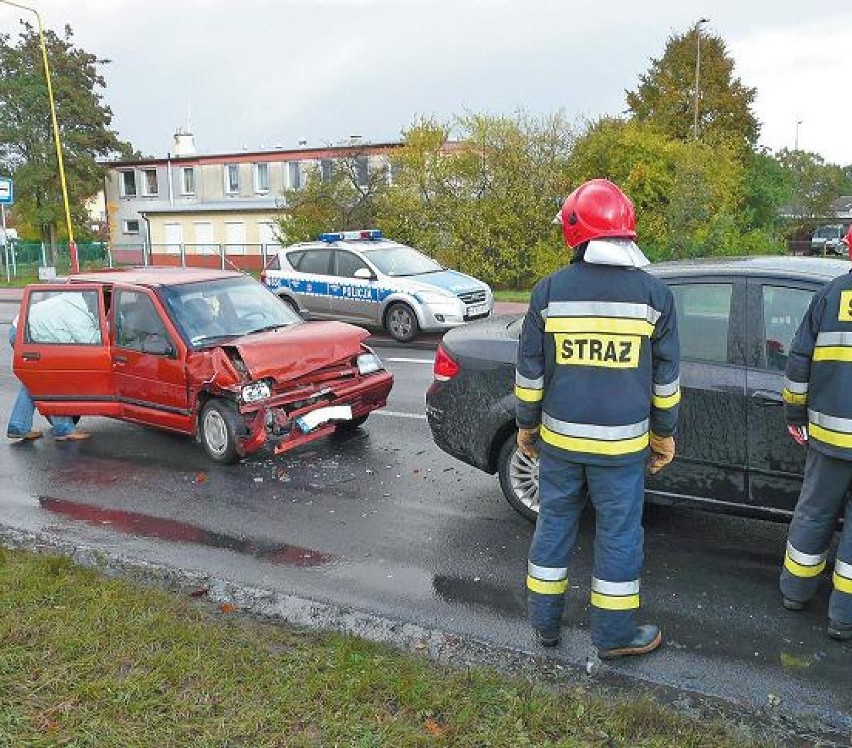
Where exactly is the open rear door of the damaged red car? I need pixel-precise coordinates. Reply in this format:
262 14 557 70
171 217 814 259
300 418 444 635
12 283 118 416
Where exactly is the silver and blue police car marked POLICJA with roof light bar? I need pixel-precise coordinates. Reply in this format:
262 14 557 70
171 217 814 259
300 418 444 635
261 229 494 343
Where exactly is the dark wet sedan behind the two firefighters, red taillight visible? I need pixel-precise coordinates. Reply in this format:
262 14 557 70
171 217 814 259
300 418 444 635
426 257 849 519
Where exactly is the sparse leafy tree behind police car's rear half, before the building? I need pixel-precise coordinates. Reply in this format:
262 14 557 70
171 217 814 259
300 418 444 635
278 143 389 243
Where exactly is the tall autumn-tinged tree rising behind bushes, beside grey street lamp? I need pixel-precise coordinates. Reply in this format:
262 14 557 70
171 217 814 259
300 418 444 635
626 28 760 148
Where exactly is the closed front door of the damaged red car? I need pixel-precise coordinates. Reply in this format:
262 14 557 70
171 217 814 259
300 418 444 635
112 285 194 433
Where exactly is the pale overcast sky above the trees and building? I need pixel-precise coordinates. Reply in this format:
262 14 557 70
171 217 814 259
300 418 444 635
0 0 852 165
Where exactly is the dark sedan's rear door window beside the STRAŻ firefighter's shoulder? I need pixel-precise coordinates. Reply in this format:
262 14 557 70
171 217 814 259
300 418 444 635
671 283 733 363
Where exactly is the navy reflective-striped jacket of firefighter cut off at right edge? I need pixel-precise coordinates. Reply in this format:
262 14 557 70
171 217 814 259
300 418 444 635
783 273 852 460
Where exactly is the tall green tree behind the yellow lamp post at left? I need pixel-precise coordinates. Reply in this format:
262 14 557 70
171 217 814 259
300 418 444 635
0 23 132 247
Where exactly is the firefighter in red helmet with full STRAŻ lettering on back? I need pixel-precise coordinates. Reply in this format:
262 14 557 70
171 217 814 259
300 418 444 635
515 179 680 659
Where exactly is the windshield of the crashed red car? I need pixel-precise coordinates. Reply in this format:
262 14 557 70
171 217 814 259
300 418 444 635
162 278 302 346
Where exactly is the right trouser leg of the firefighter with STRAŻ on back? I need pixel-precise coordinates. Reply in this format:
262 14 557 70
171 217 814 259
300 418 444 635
587 462 645 654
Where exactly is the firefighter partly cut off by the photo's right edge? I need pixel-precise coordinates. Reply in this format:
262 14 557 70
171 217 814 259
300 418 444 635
781 226 852 641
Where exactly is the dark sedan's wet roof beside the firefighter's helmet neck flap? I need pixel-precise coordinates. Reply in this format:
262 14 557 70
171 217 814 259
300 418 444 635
647 255 852 281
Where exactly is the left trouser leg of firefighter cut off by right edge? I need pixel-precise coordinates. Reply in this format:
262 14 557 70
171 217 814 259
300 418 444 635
780 448 852 610
